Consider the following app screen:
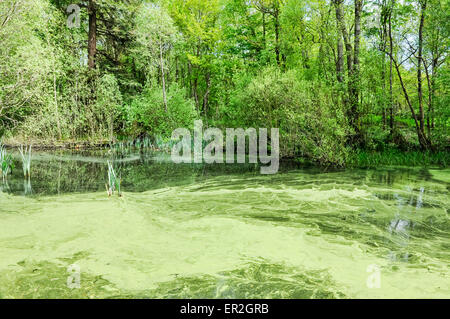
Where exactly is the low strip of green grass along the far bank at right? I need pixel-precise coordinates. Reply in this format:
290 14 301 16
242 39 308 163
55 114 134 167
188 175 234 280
347 149 450 168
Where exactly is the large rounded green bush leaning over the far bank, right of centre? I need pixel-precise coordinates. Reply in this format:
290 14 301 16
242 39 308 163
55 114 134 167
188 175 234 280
229 68 349 166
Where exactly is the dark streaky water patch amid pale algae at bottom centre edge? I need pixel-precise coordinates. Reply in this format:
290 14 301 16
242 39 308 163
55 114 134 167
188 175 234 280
133 262 346 299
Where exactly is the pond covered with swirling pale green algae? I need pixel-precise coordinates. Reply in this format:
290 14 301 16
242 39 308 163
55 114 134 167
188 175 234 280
0 151 450 298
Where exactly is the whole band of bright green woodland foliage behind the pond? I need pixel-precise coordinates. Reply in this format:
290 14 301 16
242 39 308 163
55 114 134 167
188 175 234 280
0 0 450 166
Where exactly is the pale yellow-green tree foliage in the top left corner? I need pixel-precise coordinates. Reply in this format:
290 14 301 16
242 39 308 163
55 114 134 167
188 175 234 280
0 0 50 135
